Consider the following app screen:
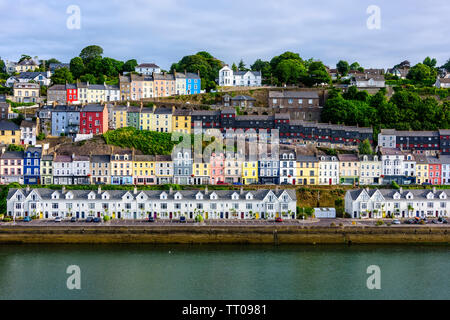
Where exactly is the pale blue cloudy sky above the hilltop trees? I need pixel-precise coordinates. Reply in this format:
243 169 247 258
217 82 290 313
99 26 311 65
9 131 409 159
0 0 450 70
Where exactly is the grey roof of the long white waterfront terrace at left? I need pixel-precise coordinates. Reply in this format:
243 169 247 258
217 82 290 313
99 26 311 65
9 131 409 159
7 188 297 201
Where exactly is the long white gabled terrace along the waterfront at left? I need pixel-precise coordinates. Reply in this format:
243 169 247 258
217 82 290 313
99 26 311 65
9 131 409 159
7 186 296 219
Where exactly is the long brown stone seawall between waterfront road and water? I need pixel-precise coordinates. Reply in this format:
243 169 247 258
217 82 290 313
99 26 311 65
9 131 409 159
0 226 450 245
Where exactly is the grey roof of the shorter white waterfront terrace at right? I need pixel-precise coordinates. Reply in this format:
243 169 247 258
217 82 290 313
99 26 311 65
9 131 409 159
347 189 450 201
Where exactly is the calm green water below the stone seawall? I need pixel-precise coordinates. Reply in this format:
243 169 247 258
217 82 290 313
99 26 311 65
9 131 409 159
0 245 450 300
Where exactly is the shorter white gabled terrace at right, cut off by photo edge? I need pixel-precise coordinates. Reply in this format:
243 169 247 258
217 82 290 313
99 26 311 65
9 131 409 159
345 188 450 218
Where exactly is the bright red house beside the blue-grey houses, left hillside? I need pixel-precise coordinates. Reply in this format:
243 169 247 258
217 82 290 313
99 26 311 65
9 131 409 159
80 104 108 135
